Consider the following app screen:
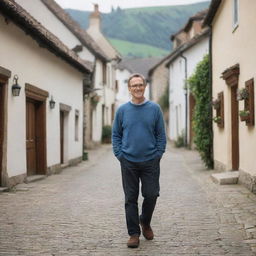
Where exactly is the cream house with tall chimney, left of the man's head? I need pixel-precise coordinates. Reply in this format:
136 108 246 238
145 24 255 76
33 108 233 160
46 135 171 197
86 4 121 142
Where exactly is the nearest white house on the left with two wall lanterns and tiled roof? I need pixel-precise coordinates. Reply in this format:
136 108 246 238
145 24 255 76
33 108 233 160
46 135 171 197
0 0 93 187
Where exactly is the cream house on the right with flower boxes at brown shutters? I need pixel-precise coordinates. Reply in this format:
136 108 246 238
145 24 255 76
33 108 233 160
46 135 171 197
204 0 256 193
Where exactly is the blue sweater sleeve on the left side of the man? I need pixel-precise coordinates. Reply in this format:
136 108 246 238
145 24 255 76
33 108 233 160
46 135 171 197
112 109 123 159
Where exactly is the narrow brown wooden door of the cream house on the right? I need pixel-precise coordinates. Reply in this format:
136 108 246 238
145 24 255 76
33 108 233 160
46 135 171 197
231 86 239 170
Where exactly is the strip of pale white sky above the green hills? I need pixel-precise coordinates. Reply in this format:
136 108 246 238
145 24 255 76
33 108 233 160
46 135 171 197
55 0 207 12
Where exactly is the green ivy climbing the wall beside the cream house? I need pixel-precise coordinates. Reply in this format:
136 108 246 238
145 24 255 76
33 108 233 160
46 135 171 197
188 55 213 168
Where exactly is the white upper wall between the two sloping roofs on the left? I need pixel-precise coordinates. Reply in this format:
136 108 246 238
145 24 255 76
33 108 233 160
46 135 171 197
16 0 95 62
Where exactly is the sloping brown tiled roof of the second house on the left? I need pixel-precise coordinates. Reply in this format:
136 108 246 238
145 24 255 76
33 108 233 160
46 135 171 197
41 0 108 61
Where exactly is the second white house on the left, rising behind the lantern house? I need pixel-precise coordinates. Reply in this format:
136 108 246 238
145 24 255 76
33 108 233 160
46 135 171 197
14 0 111 148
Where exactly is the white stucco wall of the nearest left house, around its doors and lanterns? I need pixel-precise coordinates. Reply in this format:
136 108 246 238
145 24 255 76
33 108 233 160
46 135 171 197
0 18 83 177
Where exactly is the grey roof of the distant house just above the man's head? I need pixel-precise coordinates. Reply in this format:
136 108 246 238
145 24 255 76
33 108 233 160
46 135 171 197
117 57 161 78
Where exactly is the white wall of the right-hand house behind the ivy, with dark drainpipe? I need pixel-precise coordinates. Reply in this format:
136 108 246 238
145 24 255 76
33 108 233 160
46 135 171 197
169 37 209 141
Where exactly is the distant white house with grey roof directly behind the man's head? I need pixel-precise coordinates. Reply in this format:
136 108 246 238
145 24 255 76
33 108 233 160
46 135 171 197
116 57 160 106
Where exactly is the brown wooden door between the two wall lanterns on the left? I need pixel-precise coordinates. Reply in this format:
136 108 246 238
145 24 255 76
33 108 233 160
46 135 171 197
26 100 37 176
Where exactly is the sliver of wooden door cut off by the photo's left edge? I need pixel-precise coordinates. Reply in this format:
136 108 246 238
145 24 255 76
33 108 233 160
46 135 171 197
0 83 4 186
